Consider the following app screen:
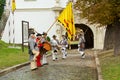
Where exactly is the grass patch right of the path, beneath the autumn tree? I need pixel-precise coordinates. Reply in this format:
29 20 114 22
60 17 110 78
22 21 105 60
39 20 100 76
99 50 120 80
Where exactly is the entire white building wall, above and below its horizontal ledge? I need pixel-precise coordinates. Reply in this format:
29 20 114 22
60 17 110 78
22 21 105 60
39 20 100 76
2 0 68 44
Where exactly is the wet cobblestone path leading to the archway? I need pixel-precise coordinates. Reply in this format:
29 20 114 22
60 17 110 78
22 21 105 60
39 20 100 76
0 49 97 80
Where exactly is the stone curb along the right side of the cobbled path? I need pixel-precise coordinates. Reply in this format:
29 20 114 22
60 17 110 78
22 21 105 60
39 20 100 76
94 51 103 80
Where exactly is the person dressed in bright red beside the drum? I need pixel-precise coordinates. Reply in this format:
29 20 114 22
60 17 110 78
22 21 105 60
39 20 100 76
36 33 43 67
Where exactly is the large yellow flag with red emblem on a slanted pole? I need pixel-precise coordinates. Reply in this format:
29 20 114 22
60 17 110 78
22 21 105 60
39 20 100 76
58 2 75 40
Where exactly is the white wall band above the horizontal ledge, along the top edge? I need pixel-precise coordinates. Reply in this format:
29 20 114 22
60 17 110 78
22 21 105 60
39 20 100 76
16 0 68 9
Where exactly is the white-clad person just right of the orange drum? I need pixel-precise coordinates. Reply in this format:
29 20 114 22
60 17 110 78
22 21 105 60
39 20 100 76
51 35 59 61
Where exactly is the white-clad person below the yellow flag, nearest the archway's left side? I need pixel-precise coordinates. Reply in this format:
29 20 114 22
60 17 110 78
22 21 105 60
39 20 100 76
60 35 68 59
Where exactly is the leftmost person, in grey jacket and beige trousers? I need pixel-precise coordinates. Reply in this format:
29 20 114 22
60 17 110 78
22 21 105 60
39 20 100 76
28 32 39 70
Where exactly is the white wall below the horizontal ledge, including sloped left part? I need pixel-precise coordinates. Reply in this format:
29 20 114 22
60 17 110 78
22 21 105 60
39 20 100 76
2 11 57 44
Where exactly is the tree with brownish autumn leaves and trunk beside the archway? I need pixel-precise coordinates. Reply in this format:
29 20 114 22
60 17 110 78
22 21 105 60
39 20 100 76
75 0 120 55
